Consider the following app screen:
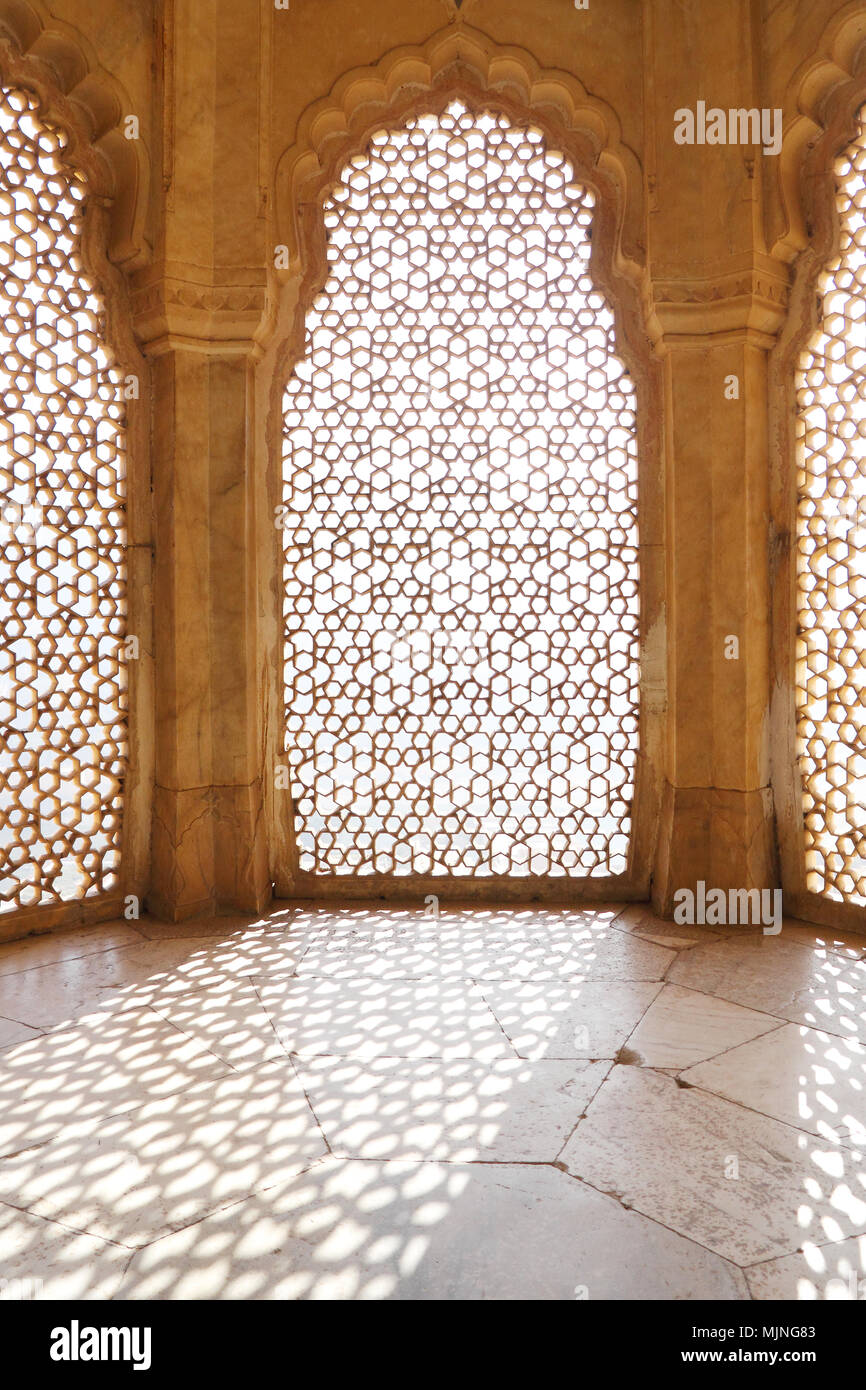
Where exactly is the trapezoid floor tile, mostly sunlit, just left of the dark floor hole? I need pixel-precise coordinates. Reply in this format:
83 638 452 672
481 980 662 1059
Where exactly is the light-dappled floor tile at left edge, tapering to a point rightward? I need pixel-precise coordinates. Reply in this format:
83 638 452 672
0 1009 228 1155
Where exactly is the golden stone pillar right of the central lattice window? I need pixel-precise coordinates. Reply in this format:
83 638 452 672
646 0 787 915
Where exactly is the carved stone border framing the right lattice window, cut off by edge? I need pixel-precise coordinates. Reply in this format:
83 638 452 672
767 3 866 931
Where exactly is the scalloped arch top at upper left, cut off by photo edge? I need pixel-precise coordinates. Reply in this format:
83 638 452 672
0 0 150 268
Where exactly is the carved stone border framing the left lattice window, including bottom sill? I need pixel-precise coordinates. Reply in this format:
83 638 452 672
0 13 153 941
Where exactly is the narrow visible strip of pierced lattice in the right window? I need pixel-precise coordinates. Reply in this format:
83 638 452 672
796 113 866 904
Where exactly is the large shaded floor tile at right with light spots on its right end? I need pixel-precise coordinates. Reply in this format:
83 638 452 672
562 1066 866 1265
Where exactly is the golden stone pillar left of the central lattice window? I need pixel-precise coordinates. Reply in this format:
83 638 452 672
133 0 271 920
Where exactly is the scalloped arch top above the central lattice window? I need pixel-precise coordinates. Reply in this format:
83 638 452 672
275 26 646 281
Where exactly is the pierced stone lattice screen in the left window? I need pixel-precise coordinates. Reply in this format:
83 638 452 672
0 89 126 910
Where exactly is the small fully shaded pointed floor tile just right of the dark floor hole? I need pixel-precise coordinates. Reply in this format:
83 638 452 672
628 984 780 1070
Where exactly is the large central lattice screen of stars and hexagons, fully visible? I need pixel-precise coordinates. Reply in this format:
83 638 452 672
279 101 638 877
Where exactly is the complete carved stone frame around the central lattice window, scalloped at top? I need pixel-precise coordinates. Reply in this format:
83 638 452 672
257 28 666 902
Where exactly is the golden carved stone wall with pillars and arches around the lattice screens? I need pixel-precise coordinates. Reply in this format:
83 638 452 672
0 0 866 935
